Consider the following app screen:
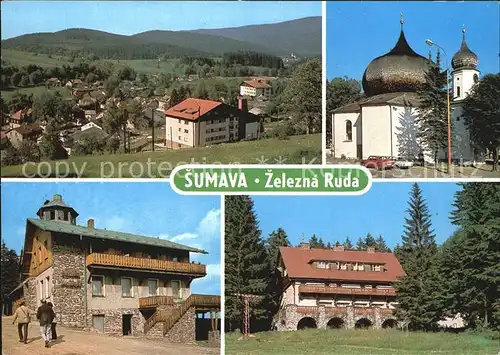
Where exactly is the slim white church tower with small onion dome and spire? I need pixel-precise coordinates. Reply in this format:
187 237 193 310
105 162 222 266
451 28 479 101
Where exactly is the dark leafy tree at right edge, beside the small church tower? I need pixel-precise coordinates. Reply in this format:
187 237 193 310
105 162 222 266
462 74 500 171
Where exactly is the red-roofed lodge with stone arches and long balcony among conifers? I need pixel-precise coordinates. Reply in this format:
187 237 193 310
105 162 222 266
276 243 404 330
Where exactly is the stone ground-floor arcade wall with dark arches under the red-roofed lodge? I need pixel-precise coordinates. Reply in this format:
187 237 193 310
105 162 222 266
276 305 395 331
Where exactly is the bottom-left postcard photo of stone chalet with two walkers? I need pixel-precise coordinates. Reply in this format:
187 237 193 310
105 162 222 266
1 182 221 355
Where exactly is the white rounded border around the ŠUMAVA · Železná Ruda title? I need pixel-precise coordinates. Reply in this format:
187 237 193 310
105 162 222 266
169 164 373 196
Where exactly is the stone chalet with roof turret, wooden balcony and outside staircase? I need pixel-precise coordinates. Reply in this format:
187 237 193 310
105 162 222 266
10 195 220 342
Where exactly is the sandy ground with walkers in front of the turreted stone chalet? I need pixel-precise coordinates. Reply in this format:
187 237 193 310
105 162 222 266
2 317 220 355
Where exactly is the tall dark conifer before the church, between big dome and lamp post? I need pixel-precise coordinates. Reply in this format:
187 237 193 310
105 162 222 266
417 52 450 170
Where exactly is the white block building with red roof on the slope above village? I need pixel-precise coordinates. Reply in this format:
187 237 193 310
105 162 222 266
165 98 260 149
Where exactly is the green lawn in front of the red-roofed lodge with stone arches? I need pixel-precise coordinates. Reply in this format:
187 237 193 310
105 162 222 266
225 329 500 355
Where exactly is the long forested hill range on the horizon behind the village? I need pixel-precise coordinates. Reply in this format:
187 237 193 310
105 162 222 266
2 18 321 59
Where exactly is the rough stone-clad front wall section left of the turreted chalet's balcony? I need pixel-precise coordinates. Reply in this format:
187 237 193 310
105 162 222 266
52 248 86 328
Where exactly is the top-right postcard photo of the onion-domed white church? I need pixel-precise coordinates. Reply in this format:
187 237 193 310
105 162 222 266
325 1 500 179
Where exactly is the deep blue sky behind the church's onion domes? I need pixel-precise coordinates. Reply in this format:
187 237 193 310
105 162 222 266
326 1 500 80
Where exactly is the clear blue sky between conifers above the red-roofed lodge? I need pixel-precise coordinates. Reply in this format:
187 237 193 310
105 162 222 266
253 182 461 248
